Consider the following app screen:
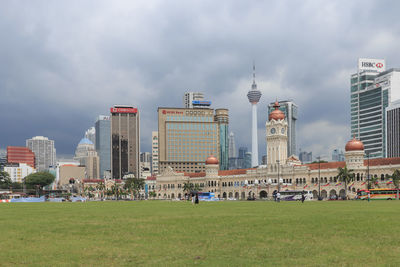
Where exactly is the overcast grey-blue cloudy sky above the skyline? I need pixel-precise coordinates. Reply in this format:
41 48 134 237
0 0 400 161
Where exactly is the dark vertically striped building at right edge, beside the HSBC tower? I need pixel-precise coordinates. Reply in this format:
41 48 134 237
386 100 400 158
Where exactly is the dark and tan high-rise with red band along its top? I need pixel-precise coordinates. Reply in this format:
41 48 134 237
110 105 140 179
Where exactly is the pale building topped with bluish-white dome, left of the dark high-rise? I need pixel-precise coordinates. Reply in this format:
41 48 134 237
74 138 100 179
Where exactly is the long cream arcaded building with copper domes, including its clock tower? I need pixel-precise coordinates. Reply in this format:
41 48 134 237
155 102 400 199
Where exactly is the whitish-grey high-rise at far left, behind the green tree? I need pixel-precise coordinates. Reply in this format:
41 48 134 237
26 136 56 171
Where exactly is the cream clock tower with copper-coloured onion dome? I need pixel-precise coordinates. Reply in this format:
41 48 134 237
265 101 288 166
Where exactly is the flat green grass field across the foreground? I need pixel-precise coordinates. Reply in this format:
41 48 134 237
0 201 400 266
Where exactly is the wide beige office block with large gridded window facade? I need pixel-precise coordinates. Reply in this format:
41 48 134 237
158 107 228 172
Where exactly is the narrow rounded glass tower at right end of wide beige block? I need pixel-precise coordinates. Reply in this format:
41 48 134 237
215 108 229 170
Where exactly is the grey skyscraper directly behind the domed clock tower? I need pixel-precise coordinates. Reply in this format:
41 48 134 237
268 100 298 156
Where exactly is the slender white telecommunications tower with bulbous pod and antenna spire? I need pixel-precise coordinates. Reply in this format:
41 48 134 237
247 64 261 167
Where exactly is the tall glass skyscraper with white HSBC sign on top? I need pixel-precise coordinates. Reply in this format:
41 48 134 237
351 59 400 158
